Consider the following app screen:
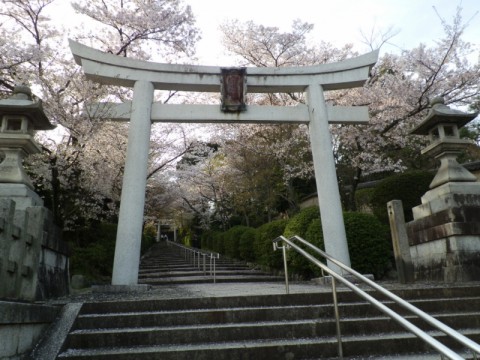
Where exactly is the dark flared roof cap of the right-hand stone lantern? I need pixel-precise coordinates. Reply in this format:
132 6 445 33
410 97 478 135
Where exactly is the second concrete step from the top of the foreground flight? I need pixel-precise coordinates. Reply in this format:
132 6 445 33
70 303 480 333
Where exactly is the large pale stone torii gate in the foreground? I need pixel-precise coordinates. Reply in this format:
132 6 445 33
70 40 378 285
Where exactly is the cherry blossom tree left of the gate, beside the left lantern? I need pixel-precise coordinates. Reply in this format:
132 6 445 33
0 0 198 228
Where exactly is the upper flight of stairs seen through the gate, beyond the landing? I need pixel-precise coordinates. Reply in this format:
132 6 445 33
138 242 284 286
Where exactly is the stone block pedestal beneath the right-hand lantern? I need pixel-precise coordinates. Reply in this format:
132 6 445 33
406 182 480 282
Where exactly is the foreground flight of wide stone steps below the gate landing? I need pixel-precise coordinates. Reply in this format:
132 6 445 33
52 285 480 360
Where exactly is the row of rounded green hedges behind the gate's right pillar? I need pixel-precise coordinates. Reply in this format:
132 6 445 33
197 206 392 279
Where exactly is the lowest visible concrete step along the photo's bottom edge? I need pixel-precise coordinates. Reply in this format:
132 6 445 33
58 333 480 360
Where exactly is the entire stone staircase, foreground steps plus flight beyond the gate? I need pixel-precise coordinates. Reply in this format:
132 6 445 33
40 240 480 360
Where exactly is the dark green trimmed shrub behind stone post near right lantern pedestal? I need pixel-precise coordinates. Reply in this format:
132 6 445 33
371 171 434 224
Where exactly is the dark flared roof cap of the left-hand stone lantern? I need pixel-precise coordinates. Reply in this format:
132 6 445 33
0 85 55 130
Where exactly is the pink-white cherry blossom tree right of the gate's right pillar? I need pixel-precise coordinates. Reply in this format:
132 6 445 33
333 9 480 206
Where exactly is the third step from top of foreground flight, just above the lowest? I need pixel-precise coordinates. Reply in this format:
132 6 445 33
67 313 480 348
